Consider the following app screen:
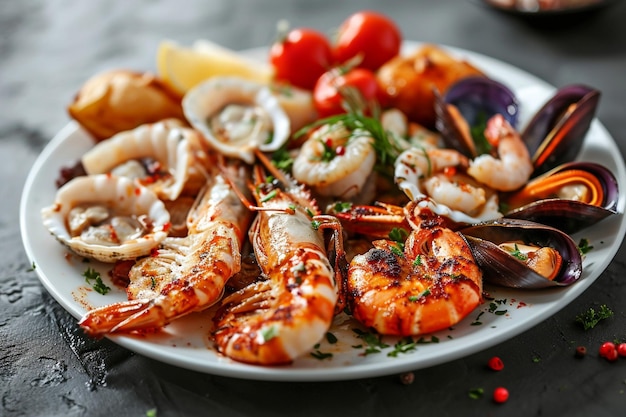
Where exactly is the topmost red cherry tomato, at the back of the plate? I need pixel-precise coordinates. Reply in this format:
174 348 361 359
335 11 402 71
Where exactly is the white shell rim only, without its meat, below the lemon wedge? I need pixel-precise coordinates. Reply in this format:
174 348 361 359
182 76 291 164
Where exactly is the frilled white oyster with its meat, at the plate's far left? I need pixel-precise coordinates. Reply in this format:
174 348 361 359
41 174 170 263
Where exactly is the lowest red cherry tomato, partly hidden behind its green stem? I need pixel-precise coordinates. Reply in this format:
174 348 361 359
313 68 386 117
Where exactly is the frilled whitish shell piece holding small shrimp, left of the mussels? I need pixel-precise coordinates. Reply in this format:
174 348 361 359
395 148 502 223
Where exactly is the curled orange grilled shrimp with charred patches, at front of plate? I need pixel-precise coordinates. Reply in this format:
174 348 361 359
347 202 482 336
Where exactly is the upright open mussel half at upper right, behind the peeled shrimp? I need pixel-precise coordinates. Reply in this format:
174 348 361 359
521 85 600 176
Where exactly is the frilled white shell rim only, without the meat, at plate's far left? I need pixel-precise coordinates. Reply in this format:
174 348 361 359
41 174 170 263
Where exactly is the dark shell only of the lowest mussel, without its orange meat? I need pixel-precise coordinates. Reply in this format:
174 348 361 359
460 218 582 289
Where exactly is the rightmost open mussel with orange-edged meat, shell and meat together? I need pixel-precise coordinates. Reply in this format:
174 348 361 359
501 162 619 234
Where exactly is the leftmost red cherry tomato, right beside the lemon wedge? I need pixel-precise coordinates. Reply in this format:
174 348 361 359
270 28 333 90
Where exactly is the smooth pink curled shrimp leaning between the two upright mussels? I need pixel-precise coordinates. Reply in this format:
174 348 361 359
467 114 534 191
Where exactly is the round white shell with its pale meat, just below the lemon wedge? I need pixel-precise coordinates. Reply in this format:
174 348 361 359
183 77 291 164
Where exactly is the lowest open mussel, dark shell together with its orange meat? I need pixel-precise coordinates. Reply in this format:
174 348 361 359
460 218 582 289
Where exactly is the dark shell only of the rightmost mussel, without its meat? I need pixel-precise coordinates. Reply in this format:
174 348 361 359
503 162 619 234
